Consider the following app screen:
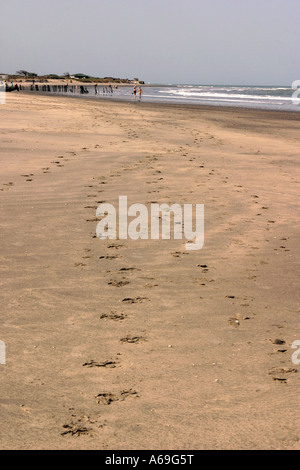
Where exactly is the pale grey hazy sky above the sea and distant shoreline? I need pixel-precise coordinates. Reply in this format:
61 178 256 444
0 0 300 85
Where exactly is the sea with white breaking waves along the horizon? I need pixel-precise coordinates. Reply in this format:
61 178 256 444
28 80 300 111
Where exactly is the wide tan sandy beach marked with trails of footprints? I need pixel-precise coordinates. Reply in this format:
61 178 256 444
0 93 300 450
